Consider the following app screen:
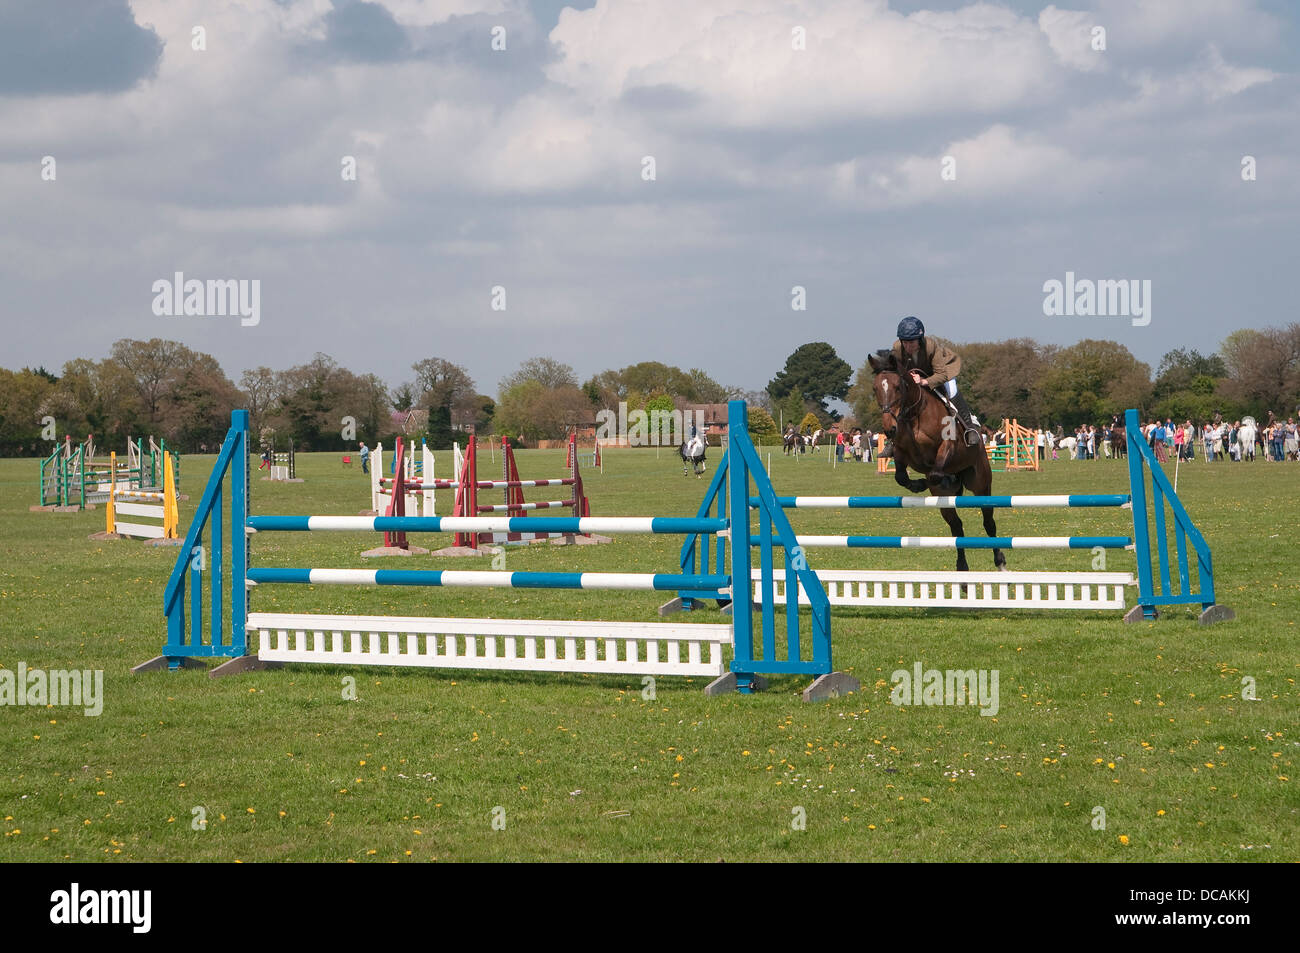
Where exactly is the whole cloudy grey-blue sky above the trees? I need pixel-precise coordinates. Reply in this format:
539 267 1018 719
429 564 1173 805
0 0 1300 393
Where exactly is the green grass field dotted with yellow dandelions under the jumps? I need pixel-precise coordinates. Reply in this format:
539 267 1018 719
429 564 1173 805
0 439 1300 862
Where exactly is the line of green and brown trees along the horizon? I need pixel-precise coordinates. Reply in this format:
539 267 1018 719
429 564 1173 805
0 324 1300 456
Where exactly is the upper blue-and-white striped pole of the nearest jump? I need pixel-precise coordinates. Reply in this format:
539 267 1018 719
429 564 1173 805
247 516 728 534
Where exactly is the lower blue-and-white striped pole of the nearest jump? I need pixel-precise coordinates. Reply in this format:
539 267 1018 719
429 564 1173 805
244 568 731 592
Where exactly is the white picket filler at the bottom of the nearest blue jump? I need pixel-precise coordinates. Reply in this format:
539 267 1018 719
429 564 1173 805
248 612 732 679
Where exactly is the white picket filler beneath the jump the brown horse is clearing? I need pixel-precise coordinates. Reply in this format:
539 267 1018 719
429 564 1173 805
753 569 1138 610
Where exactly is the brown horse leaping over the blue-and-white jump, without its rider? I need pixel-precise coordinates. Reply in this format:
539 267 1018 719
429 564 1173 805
867 351 1006 572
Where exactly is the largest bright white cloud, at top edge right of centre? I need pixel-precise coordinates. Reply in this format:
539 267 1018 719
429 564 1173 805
547 0 1054 126
